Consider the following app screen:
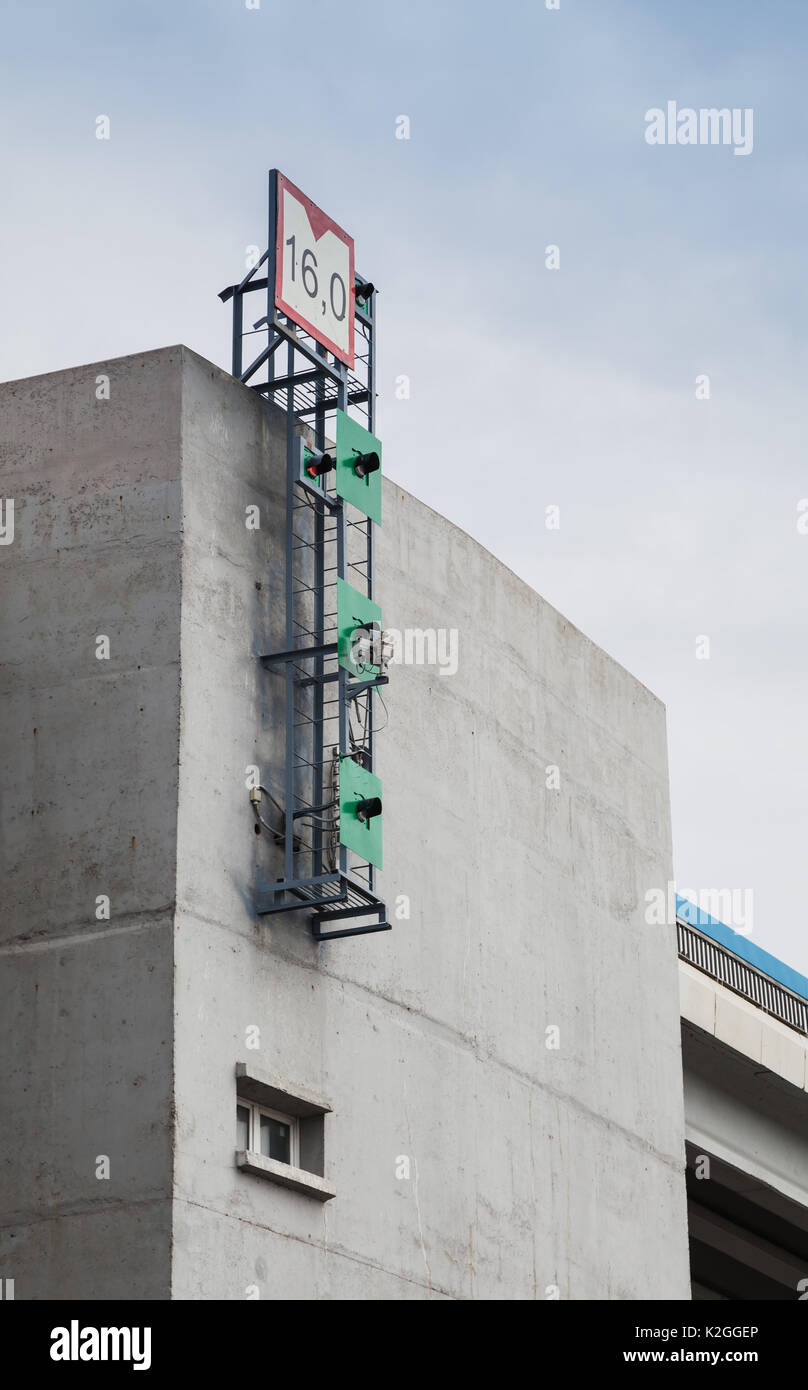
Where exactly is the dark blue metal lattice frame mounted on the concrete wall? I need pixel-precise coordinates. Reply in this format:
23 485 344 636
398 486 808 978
220 170 391 941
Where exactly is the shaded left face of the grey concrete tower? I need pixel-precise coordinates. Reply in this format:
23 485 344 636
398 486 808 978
0 349 181 1300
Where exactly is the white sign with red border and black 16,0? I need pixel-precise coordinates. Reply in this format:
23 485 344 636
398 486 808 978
270 171 355 367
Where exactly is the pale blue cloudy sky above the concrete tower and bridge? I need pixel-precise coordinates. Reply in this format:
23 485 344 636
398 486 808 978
0 0 808 973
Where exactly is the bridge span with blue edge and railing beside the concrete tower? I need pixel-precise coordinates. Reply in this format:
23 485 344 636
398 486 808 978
679 901 808 1301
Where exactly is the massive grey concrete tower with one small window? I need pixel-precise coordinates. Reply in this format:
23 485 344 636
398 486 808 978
0 346 808 1300
